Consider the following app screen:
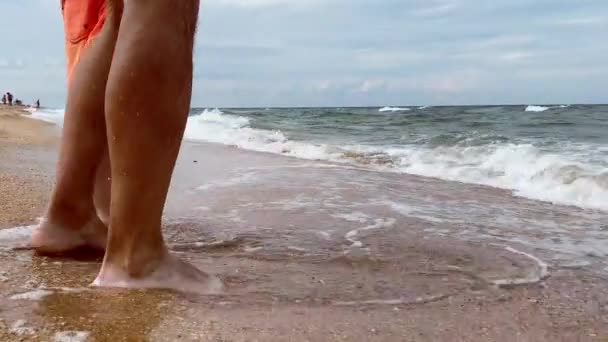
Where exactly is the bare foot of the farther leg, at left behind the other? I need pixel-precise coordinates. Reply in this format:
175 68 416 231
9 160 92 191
32 216 108 255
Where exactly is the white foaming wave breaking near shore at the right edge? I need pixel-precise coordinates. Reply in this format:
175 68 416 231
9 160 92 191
387 143 608 210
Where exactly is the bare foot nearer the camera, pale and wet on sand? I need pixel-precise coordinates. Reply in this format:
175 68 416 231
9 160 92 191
92 253 224 295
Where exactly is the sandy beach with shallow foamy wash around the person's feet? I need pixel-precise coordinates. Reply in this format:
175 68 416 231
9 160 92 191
0 108 608 341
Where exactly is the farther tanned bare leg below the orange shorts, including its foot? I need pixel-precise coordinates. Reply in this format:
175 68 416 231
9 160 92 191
32 1 122 254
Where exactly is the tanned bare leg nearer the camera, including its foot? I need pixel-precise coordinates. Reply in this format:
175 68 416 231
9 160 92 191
93 0 221 293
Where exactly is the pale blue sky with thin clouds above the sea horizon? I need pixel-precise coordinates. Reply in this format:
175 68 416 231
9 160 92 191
0 0 608 107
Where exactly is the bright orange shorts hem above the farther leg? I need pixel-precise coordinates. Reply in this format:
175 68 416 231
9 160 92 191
61 0 106 86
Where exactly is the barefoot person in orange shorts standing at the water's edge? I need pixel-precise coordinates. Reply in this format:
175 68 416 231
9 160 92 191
32 0 221 293
